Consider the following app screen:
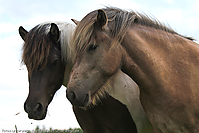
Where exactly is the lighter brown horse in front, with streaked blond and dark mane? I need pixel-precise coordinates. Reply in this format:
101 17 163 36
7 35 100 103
67 8 199 133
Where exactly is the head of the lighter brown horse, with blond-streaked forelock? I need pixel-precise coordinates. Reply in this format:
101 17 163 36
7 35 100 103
67 10 122 107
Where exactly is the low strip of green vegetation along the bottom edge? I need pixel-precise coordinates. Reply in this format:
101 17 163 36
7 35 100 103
27 126 83 133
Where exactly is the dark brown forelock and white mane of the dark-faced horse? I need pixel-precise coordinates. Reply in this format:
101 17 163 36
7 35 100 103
22 22 75 73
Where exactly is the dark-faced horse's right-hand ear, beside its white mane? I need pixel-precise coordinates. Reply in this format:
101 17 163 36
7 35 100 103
50 23 60 42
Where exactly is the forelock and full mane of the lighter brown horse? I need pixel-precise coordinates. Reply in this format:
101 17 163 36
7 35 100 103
73 7 194 52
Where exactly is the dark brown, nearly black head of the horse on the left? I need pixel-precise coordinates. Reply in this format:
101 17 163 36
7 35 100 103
19 23 65 120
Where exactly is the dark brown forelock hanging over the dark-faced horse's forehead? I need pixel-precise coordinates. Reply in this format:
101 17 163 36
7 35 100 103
22 24 51 73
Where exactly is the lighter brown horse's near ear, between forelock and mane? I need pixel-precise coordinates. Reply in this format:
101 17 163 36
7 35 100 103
97 9 108 28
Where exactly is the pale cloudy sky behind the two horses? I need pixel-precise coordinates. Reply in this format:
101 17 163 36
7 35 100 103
0 0 199 132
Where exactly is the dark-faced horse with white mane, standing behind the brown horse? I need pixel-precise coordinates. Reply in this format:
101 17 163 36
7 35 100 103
19 22 152 133
